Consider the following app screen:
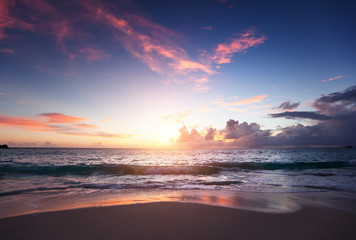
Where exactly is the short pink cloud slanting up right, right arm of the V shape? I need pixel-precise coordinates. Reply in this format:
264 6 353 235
211 31 266 64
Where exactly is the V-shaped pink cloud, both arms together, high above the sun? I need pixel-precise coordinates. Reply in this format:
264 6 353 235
80 2 265 92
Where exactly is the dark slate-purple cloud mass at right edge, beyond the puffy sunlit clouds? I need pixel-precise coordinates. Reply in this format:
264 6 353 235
271 86 356 146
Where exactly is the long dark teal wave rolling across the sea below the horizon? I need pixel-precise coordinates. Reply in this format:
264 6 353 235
0 161 356 176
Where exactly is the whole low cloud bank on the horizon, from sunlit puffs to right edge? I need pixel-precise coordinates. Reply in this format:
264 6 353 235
176 86 356 147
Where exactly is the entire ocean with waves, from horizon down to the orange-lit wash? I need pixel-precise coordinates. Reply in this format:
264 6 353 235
0 148 356 217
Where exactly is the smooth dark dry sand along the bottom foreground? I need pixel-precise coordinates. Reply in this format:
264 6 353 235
0 202 356 240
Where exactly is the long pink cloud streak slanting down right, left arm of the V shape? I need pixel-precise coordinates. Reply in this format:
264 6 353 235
85 4 214 79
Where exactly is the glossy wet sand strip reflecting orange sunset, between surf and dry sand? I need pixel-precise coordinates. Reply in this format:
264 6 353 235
0 189 356 219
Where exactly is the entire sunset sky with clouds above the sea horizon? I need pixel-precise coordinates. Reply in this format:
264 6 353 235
0 0 356 148
